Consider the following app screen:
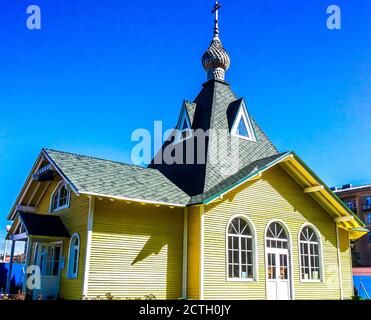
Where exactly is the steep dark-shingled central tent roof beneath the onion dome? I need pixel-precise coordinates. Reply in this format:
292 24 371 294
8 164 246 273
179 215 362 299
150 80 279 197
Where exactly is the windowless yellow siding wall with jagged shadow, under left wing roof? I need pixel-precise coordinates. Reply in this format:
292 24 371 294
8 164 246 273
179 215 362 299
88 200 184 299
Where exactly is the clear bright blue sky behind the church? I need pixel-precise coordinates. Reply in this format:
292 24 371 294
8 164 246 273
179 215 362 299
0 0 371 250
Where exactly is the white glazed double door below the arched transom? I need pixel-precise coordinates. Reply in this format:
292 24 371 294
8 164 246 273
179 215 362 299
267 249 290 300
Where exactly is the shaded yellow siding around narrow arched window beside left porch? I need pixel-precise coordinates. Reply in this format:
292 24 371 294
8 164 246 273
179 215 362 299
37 181 89 300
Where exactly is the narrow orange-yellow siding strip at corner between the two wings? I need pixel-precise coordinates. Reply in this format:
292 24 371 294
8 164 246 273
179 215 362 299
187 207 200 300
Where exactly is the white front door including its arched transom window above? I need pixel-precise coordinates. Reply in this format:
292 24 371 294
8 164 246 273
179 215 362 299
265 222 291 300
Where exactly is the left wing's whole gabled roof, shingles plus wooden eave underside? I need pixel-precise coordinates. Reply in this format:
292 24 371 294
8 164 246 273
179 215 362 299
8 149 189 220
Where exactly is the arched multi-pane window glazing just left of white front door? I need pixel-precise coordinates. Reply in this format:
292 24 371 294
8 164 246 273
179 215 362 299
227 217 255 279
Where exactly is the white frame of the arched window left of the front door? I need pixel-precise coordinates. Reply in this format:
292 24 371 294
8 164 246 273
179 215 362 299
225 214 259 282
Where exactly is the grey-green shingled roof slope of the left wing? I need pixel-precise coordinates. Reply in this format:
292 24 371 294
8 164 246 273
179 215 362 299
44 149 190 206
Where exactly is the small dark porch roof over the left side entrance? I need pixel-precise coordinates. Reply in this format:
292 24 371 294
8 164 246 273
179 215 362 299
7 212 70 238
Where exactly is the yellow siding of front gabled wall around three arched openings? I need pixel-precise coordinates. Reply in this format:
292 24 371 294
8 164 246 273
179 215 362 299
199 167 351 299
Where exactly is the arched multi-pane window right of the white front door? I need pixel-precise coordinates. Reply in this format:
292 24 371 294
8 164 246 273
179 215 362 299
299 226 321 281
